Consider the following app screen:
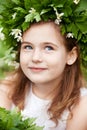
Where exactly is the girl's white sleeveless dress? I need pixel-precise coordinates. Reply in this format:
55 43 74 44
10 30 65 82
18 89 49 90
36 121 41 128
19 88 87 130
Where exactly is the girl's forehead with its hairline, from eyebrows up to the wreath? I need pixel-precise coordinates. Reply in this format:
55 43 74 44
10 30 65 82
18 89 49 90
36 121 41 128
23 23 63 43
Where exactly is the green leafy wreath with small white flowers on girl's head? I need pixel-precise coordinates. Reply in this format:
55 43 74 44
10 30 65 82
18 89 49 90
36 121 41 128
0 0 87 65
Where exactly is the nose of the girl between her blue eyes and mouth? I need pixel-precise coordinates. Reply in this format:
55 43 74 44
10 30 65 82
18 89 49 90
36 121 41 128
32 49 42 62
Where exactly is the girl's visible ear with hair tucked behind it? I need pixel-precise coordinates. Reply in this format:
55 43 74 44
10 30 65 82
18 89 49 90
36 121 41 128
67 47 78 65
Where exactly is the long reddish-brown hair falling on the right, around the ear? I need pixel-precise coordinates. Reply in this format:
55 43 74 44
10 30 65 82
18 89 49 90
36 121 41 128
49 33 84 124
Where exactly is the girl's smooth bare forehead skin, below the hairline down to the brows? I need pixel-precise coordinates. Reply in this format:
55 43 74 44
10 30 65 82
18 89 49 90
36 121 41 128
23 26 62 47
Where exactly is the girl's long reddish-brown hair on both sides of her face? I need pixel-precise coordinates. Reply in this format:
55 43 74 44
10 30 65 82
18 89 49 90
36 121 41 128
2 22 83 124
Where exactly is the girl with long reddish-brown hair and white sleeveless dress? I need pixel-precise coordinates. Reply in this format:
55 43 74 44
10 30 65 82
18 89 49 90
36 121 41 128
0 21 87 130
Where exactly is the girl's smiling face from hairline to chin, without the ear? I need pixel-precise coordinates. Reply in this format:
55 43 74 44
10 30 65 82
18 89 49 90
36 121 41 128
20 23 68 84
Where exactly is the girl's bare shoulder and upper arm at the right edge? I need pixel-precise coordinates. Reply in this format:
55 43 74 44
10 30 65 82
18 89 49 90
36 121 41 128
67 88 87 130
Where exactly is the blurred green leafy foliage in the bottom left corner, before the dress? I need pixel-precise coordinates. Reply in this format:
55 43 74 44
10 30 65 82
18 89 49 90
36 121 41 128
0 108 43 130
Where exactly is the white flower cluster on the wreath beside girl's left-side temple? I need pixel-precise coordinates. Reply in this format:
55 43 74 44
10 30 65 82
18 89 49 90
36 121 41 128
10 29 22 42
